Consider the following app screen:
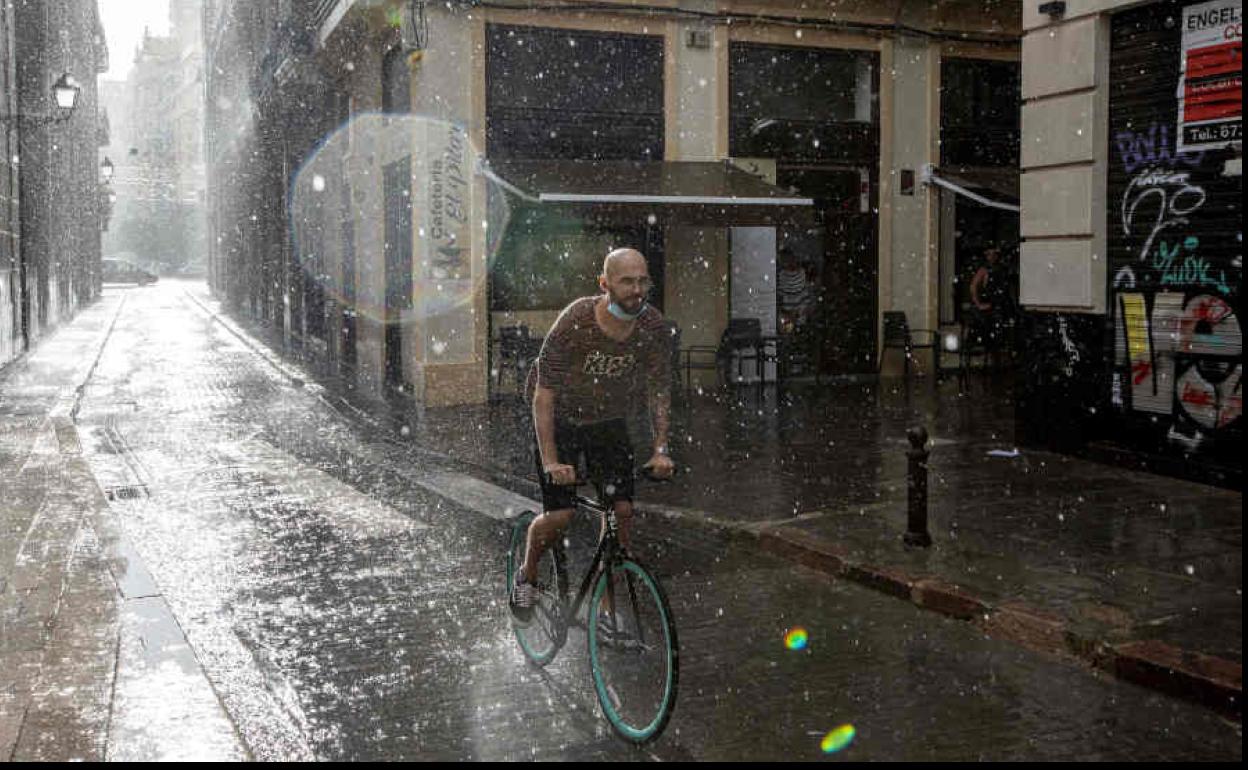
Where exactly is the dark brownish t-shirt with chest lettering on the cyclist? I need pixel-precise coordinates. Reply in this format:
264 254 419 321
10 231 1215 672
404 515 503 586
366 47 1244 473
528 297 671 424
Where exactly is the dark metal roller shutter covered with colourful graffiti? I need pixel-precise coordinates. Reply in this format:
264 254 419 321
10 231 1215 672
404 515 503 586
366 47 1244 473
1106 2 1243 465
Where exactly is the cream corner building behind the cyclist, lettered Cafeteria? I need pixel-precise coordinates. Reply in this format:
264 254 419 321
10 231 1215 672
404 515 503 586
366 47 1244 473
205 0 1021 404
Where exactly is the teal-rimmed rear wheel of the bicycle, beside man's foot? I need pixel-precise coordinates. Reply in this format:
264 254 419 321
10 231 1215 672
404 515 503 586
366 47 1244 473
507 510 568 665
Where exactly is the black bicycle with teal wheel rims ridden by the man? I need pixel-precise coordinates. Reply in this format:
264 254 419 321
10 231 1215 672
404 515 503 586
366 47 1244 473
507 469 680 744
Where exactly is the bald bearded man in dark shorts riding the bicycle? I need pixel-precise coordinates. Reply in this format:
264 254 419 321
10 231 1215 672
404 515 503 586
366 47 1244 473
510 248 674 623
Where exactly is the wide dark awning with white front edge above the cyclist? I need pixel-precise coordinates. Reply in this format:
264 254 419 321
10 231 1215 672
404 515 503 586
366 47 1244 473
482 161 814 227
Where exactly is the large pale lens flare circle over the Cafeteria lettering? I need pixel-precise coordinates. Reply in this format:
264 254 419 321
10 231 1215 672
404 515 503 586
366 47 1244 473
286 112 512 364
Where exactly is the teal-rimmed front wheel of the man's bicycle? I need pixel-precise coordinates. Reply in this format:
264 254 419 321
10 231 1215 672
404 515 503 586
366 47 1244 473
587 559 679 744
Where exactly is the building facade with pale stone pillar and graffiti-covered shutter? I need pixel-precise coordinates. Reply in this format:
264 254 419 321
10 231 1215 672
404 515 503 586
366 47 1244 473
1018 0 1243 480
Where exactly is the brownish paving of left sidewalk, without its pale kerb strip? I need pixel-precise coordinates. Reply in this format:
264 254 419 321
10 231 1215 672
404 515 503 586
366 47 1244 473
0 296 121 761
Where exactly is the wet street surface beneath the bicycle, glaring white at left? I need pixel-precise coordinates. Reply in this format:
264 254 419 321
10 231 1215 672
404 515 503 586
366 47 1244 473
0 281 1242 761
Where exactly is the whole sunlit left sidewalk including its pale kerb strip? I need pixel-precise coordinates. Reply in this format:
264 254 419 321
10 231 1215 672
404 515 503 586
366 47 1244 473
0 290 246 761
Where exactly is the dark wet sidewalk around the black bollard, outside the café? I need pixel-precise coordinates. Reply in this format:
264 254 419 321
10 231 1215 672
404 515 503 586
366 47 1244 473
361 381 1243 718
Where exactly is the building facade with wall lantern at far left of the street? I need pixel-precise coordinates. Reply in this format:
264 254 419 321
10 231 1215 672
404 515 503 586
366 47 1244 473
0 0 109 364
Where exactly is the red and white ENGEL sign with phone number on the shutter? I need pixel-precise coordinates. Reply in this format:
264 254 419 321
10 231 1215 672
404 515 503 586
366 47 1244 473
1178 0 1243 151
